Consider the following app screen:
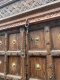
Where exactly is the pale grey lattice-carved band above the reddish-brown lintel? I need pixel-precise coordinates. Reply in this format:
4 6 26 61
0 0 56 19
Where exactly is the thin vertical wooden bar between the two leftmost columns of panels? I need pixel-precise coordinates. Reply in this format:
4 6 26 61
4 33 8 80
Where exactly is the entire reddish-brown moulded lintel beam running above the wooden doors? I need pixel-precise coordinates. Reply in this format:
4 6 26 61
0 7 60 30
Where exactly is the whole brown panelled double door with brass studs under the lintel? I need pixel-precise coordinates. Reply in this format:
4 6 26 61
0 24 60 80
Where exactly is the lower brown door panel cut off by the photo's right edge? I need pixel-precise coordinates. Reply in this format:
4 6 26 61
54 57 60 80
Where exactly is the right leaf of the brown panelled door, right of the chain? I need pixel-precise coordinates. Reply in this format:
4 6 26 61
27 24 60 80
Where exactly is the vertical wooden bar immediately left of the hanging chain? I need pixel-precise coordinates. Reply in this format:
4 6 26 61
20 28 26 80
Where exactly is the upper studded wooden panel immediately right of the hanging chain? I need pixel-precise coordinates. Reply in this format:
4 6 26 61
29 30 45 49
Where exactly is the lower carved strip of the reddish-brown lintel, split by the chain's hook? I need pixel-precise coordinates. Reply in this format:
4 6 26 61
0 8 60 30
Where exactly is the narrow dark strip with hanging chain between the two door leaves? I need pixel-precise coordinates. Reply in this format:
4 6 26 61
25 19 29 80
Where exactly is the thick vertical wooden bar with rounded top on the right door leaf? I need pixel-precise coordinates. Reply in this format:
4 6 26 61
44 26 54 80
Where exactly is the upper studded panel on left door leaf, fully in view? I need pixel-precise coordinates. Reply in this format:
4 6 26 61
9 33 20 51
